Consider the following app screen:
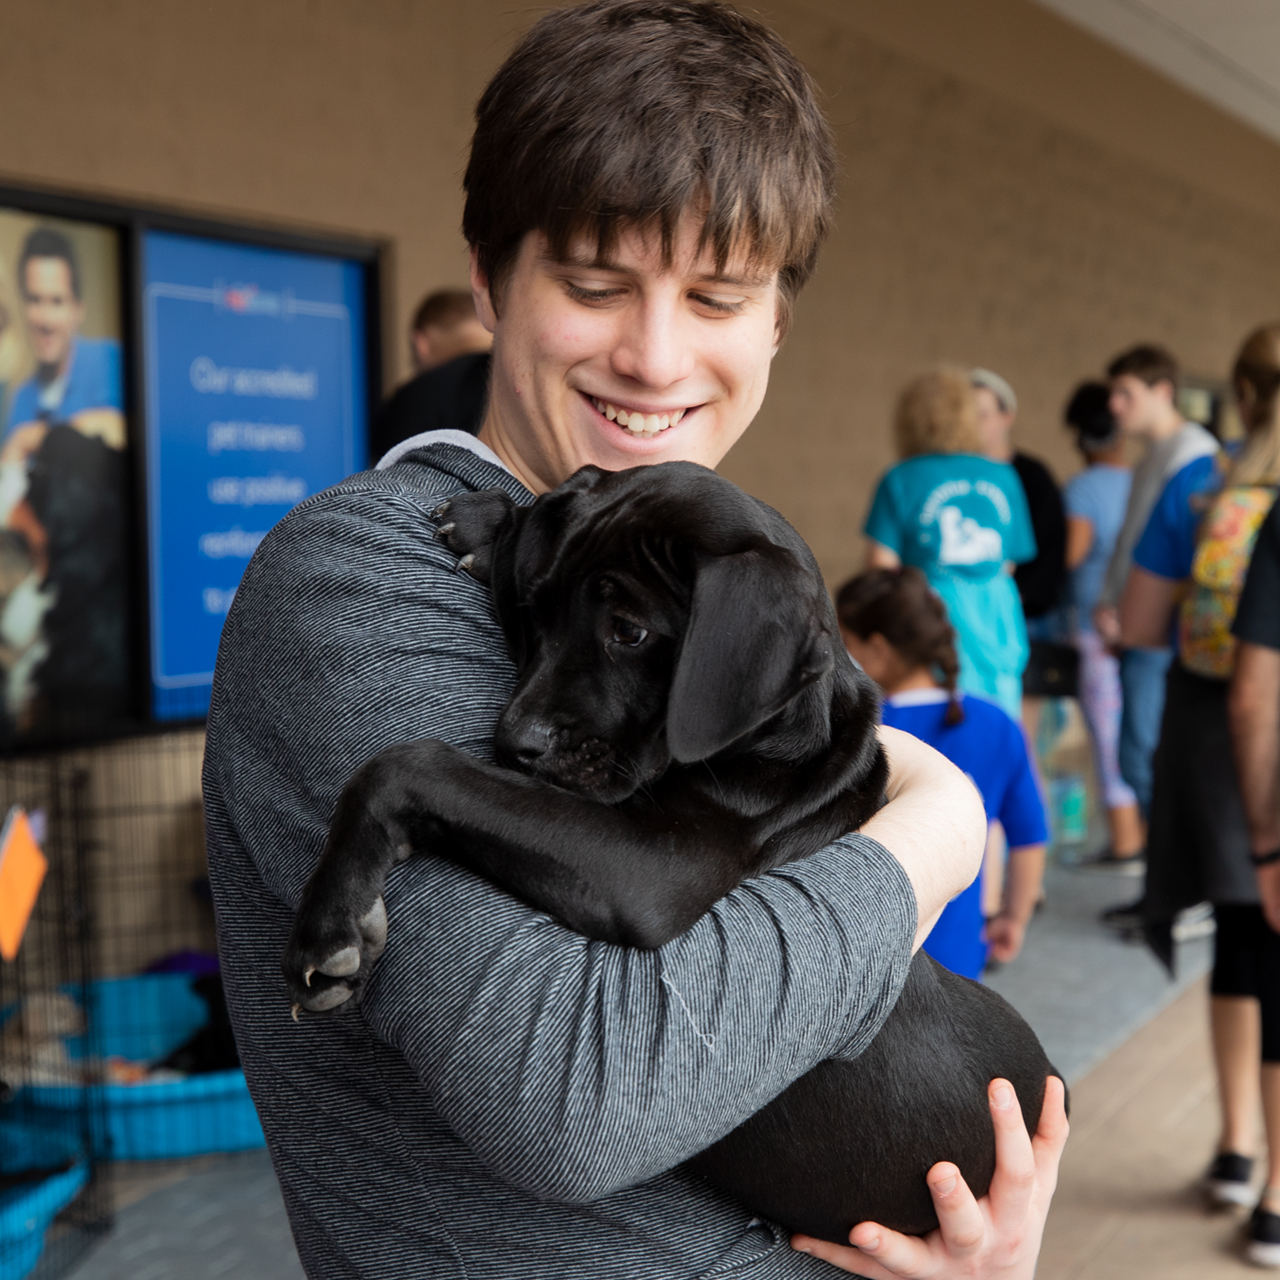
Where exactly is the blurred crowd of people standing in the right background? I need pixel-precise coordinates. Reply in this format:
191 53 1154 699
836 335 1280 1266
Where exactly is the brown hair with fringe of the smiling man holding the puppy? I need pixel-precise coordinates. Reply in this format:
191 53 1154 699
462 0 836 326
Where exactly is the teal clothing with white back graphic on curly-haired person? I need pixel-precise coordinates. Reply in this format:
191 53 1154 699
865 453 1036 717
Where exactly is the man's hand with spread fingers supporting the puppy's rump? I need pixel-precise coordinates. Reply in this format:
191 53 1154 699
791 1076 1068 1280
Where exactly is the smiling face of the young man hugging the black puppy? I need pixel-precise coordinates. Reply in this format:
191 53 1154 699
472 219 778 492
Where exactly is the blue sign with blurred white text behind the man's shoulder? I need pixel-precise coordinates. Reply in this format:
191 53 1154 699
142 232 366 719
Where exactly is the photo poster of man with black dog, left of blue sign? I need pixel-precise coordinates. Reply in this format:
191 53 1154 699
0 207 137 750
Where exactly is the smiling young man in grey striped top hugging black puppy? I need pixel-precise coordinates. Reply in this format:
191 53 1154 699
205 0 1065 1280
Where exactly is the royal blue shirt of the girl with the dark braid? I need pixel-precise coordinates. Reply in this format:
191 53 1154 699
882 689 1048 978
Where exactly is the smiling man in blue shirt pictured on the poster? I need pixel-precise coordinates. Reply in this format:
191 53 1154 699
0 227 124 463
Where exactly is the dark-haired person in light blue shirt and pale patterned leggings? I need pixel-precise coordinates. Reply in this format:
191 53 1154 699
1064 383 1147 873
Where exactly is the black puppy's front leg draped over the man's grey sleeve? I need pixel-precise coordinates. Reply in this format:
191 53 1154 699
283 739 746 1012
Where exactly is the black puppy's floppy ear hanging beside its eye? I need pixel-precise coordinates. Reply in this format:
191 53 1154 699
667 544 835 764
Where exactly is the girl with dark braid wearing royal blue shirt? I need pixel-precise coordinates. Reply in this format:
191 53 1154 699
836 568 1048 978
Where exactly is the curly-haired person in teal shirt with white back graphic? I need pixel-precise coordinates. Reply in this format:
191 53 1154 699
864 369 1036 719
